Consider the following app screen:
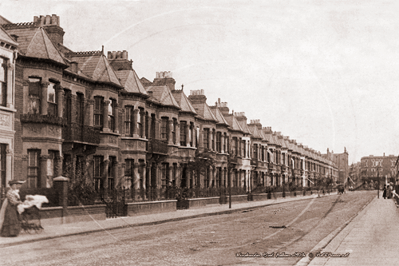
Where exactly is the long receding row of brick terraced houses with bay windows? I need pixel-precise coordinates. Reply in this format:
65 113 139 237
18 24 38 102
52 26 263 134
0 15 344 206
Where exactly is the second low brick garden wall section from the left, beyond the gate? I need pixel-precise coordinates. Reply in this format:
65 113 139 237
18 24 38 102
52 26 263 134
127 200 177 216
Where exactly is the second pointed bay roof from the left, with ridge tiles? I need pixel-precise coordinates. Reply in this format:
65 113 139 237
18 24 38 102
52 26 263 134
71 51 121 86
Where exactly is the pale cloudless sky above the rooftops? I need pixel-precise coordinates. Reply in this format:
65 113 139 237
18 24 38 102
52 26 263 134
0 0 399 164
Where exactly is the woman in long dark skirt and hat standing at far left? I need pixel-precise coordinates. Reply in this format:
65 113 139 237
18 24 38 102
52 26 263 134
0 180 24 237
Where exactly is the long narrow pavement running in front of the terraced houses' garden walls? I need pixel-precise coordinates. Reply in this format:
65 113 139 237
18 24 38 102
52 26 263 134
0 192 328 248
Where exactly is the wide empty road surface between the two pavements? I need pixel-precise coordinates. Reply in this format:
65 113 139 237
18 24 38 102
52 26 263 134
1 191 375 265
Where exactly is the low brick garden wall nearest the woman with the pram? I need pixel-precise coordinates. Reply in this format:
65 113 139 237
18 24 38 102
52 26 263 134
40 204 106 227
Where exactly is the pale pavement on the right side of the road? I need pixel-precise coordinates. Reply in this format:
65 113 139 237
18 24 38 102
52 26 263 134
304 193 399 266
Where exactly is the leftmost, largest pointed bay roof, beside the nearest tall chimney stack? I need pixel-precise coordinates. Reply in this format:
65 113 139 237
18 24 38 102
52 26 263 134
7 27 65 65
